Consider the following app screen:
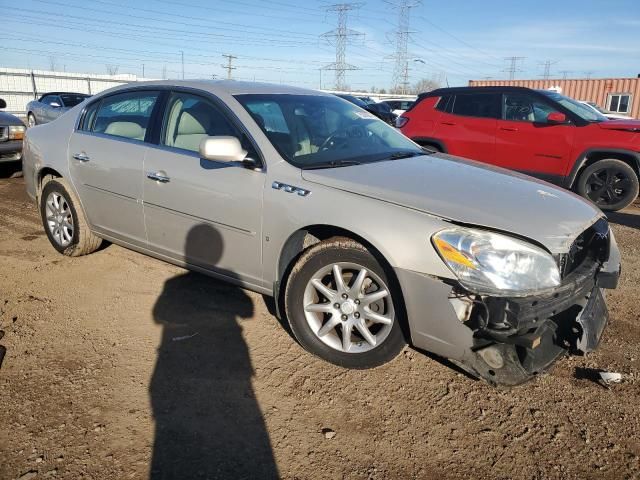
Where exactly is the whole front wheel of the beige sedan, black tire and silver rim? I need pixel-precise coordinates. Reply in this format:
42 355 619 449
285 237 406 369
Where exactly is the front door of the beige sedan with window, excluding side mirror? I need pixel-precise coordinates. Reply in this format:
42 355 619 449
144 91 265 284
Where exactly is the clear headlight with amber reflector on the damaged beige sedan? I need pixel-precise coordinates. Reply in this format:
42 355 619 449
432 228 560 297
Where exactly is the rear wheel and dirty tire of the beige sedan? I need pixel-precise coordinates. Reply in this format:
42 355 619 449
40 177 102 257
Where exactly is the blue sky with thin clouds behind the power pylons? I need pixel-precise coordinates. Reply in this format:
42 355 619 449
0 0 640 89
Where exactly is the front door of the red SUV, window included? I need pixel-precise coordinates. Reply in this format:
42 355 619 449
496 92 575 182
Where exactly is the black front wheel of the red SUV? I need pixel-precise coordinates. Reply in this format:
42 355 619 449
577 159 639 211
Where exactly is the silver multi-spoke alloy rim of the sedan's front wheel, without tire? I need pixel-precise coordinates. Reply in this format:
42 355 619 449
303 262 395 353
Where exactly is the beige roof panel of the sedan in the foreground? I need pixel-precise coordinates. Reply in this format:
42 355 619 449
101 80 330 96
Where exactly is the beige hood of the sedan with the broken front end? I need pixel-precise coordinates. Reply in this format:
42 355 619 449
302 154 602 254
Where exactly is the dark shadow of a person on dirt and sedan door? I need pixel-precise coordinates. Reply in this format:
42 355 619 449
149 224 278 480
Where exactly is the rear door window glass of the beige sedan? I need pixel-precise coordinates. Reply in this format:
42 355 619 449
91 91 159 141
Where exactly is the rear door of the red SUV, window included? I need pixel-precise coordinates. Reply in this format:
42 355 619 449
435 92 500 163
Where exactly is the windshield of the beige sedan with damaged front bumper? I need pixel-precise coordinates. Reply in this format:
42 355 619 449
235 94 424 169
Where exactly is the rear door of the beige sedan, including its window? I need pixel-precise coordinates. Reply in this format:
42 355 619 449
69 90 159 247
